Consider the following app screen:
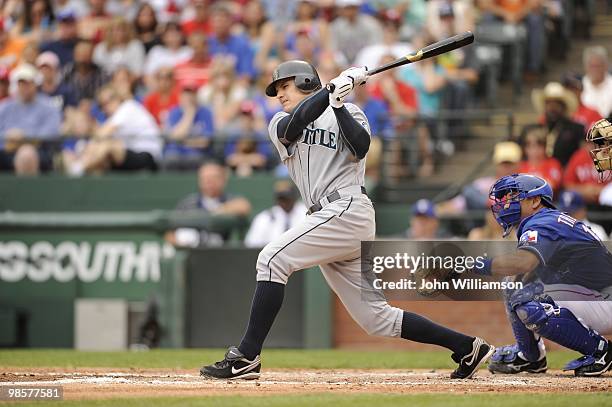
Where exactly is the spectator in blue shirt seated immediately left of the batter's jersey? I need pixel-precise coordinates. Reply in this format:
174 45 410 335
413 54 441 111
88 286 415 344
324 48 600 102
225 101 271 177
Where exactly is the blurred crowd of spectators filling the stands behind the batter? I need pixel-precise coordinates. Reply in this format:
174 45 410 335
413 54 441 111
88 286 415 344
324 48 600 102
0 0 612 180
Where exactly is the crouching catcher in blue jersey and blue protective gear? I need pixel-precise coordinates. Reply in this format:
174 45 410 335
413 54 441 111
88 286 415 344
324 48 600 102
473 174 612 376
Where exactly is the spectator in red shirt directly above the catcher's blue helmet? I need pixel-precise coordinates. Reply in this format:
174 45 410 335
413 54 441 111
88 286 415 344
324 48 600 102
519 127 563 192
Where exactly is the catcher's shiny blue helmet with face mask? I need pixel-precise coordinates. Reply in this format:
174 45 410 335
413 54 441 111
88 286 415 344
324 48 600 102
489 174 555 237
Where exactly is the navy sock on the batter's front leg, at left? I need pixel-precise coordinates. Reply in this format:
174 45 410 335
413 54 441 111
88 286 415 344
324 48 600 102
238 281 285 360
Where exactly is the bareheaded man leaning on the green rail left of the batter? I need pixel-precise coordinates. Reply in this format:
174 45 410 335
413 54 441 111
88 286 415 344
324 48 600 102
165 162 251 247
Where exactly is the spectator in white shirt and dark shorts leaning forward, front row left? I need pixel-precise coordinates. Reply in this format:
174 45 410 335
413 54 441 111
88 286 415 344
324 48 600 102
65 85 161 175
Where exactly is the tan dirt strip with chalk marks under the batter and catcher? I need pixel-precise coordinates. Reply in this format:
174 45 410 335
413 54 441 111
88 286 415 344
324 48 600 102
0 368 612 399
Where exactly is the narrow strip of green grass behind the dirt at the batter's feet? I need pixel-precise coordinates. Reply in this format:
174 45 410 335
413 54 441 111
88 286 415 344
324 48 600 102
0 349 578 369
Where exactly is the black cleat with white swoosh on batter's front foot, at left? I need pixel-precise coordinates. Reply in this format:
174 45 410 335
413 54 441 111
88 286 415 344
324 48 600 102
200 346 261 380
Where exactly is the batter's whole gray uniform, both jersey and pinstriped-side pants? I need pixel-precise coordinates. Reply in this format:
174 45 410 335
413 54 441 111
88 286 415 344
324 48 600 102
257 104 403 337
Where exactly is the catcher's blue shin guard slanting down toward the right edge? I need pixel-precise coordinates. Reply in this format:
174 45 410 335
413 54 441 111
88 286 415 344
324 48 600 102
515 300 606 355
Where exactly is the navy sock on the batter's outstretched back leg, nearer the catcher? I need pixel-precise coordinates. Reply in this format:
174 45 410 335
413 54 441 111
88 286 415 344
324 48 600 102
401 311 474 357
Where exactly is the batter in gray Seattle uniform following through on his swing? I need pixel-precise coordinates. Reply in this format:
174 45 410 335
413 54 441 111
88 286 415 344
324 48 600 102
200 61 494 379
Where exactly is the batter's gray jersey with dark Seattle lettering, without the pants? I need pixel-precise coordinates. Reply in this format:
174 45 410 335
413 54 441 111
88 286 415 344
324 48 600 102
268 103 370 206
